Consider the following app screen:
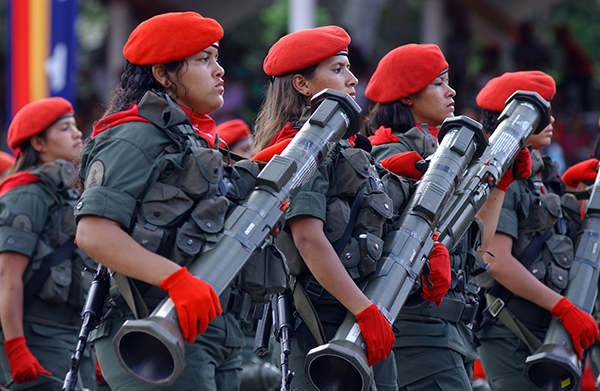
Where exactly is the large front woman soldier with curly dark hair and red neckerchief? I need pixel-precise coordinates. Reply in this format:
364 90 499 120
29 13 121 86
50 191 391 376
75 12 255 390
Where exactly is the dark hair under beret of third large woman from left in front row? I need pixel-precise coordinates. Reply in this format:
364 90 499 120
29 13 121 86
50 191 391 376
365 100 415 136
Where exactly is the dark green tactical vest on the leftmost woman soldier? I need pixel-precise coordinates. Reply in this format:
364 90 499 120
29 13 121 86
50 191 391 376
23 160 95 328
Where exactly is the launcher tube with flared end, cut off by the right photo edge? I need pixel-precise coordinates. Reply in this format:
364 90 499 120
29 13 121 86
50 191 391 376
523 167 600 391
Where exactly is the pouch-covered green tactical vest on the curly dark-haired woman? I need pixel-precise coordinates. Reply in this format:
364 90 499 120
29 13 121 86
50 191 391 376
118 91 260 309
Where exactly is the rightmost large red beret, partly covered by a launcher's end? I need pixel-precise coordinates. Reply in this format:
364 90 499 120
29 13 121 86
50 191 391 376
476 71 556 111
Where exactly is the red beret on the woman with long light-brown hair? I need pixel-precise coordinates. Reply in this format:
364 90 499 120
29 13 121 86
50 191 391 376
263 26 350 76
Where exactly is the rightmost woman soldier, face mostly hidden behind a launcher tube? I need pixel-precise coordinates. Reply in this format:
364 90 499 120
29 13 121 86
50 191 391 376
477 71 599 391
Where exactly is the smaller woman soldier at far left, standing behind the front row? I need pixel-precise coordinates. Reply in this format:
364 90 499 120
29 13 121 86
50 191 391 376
0 98 94 390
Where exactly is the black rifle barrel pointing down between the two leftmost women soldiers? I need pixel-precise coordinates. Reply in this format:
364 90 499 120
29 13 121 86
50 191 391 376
62 264 108 391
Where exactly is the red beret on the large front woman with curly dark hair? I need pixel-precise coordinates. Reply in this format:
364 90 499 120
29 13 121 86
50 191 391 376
123 12 223 65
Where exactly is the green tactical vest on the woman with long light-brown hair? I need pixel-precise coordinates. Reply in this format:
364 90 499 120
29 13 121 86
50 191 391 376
276 144 410 281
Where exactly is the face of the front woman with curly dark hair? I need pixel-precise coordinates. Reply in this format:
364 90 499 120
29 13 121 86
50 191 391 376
169 46 225 115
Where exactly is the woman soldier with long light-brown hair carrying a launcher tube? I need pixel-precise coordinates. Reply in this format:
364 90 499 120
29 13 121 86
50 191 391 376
255 26 448 390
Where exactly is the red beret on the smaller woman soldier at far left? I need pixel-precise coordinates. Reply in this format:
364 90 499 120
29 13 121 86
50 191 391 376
7 97 74 149
